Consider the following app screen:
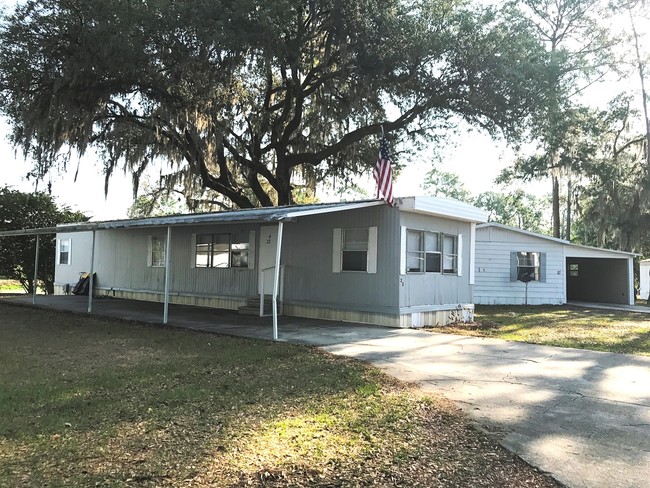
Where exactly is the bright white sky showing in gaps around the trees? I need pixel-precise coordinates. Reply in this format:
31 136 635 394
0 0 634 220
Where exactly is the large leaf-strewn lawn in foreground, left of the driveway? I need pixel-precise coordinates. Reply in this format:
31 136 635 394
0 303 558 487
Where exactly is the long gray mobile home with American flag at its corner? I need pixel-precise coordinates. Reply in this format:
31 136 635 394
55 197 487 327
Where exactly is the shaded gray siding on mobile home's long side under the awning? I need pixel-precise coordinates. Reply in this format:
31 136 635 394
57 207 399 313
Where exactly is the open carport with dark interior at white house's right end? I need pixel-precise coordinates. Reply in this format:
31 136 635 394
564 244 636 305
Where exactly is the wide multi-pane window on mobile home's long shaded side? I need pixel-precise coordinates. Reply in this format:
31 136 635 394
194 234 250 268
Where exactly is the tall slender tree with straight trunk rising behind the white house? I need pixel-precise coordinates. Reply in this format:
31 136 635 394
504 0 617 238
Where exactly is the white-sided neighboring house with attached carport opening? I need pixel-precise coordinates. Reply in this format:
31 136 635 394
474 223 636 305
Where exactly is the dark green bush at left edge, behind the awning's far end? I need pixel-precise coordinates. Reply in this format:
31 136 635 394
0 187 88 294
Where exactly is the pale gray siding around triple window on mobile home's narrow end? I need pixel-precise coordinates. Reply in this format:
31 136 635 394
397 212 472 307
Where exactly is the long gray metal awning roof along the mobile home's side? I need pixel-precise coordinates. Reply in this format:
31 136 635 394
0 200 386 237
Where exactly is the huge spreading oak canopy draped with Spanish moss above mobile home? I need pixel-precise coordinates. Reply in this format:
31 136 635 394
0 0 546 207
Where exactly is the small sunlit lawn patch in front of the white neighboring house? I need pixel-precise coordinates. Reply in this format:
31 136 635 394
434 305 650 356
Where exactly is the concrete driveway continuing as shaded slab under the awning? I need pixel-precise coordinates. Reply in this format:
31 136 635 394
5 297 650 488
